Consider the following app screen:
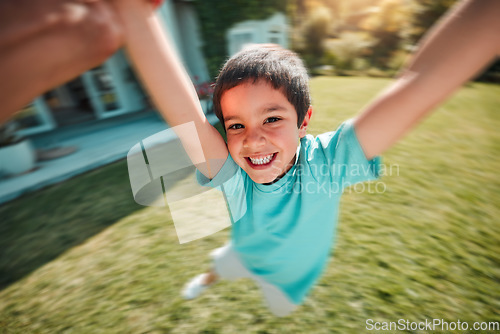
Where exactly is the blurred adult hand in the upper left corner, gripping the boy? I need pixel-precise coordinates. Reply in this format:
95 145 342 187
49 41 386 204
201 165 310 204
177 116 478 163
0 0 163 124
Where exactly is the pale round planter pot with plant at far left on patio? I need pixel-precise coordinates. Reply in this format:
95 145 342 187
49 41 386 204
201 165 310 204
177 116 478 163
0 121 35 177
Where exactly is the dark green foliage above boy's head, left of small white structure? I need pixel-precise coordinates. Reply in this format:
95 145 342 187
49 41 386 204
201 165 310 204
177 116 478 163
194 0 293 77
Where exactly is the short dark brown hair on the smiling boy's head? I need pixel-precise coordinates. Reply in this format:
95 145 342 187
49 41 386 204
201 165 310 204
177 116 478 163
213 44 311 128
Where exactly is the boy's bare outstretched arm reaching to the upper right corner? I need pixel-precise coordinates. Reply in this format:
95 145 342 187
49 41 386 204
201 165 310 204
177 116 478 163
354 0 500 159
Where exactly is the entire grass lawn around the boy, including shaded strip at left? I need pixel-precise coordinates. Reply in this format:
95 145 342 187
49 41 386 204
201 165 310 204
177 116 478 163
0 77 500 333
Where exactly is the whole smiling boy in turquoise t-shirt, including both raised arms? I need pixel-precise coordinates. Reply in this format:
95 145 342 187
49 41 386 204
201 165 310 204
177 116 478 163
118 0 500 316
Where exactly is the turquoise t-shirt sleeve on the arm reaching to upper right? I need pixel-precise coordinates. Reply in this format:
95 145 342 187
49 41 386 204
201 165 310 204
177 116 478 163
316 119 381 188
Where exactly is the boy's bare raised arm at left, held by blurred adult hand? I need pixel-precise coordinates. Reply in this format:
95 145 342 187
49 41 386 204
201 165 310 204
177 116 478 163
117 0 228 178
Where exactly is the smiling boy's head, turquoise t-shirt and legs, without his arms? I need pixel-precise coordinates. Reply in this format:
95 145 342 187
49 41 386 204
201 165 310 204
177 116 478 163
183 46 378 315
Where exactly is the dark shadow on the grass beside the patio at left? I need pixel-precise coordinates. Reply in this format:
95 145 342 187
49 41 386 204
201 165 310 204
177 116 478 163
0 161 143 289
